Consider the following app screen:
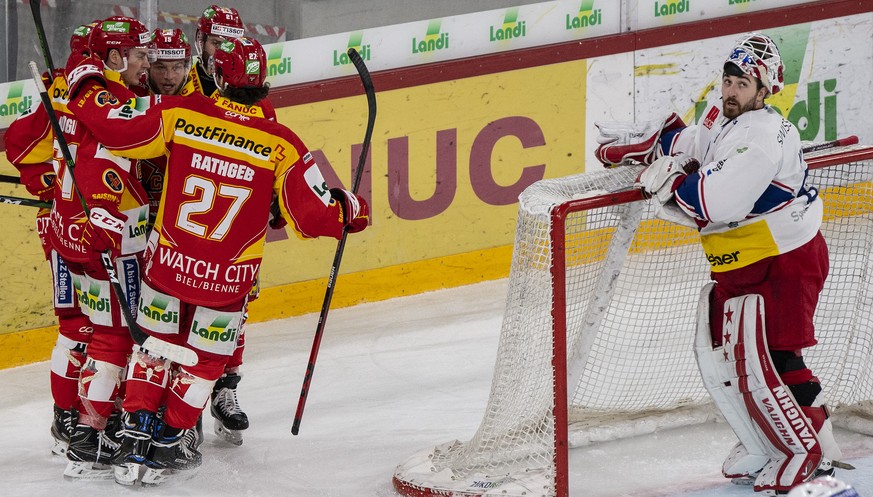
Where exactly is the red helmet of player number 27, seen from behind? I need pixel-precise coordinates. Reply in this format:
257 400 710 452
214 37 267 88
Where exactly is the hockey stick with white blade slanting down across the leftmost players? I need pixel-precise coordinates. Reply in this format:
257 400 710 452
30 61 197 366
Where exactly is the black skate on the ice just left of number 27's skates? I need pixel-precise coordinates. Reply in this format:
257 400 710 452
64 425 118 480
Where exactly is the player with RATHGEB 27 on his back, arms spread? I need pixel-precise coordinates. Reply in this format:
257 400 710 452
71 38 369 483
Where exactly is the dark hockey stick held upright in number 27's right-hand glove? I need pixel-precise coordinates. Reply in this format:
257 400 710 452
291 48 376 435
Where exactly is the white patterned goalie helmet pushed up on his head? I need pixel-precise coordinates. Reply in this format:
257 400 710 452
725 33 785 95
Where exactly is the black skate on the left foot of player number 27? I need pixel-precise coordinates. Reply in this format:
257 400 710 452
112 409 158 485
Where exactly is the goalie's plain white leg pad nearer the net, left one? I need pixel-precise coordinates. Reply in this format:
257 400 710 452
694 282 770 478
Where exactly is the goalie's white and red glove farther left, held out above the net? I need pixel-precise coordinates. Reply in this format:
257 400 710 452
594 112 685 168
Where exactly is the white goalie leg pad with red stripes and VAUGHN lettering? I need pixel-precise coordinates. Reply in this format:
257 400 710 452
722 294 822 492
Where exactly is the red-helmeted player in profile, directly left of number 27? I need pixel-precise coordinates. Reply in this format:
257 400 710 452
53 16 152 479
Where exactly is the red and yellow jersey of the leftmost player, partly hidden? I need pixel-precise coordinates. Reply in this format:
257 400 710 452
5 77 87 262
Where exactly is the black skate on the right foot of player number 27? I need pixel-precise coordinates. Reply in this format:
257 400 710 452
142 422 203 486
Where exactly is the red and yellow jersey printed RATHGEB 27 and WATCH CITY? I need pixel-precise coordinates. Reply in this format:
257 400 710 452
75 85 343 307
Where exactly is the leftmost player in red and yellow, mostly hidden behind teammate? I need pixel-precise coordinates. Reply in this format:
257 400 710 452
4 23 101 455
